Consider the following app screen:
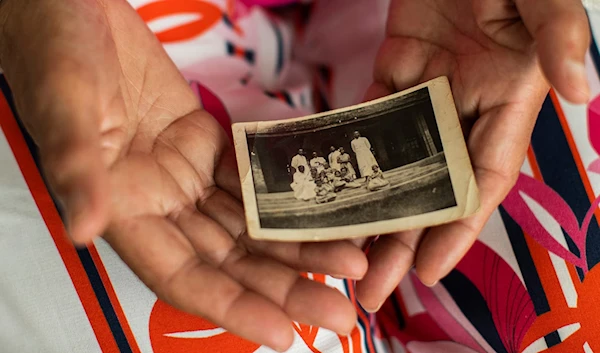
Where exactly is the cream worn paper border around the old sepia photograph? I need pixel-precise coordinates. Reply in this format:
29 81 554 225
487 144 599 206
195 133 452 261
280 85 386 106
232 77 479 242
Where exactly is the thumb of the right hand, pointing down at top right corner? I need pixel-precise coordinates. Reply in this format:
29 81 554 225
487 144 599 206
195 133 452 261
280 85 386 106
515 0 590 103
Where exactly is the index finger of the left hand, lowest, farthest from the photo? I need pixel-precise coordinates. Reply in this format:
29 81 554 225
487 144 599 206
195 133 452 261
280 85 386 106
105 216 294 351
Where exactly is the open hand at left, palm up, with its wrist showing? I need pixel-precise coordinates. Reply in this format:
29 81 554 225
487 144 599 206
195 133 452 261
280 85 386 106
0 0 367 350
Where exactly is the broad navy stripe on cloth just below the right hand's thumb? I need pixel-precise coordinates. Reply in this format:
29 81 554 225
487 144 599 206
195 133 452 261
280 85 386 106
531 97 600 272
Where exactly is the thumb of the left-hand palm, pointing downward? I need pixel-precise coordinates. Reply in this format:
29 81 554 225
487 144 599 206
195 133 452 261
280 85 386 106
35 76 110 245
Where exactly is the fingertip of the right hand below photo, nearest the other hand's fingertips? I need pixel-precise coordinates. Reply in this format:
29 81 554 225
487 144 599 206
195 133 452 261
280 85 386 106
356 230 423 312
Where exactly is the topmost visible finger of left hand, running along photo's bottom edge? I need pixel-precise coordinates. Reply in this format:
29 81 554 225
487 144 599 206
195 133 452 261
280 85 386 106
245 238 368 279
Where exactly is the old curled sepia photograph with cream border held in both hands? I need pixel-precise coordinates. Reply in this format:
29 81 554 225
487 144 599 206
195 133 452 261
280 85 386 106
234 79 478 241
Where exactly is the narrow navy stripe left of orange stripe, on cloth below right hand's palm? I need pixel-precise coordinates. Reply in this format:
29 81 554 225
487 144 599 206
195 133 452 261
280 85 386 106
499 207 561 347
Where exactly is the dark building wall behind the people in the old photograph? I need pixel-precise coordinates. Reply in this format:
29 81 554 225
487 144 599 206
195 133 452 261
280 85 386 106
249 94 443 193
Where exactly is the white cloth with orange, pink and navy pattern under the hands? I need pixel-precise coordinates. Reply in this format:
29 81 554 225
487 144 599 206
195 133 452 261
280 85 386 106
0 0 600 353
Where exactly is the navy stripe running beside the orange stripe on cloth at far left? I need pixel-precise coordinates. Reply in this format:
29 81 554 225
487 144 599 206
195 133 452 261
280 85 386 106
0 75 132 353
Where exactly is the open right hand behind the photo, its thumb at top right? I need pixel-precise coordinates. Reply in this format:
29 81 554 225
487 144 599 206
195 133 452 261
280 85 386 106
356 0 589 311
